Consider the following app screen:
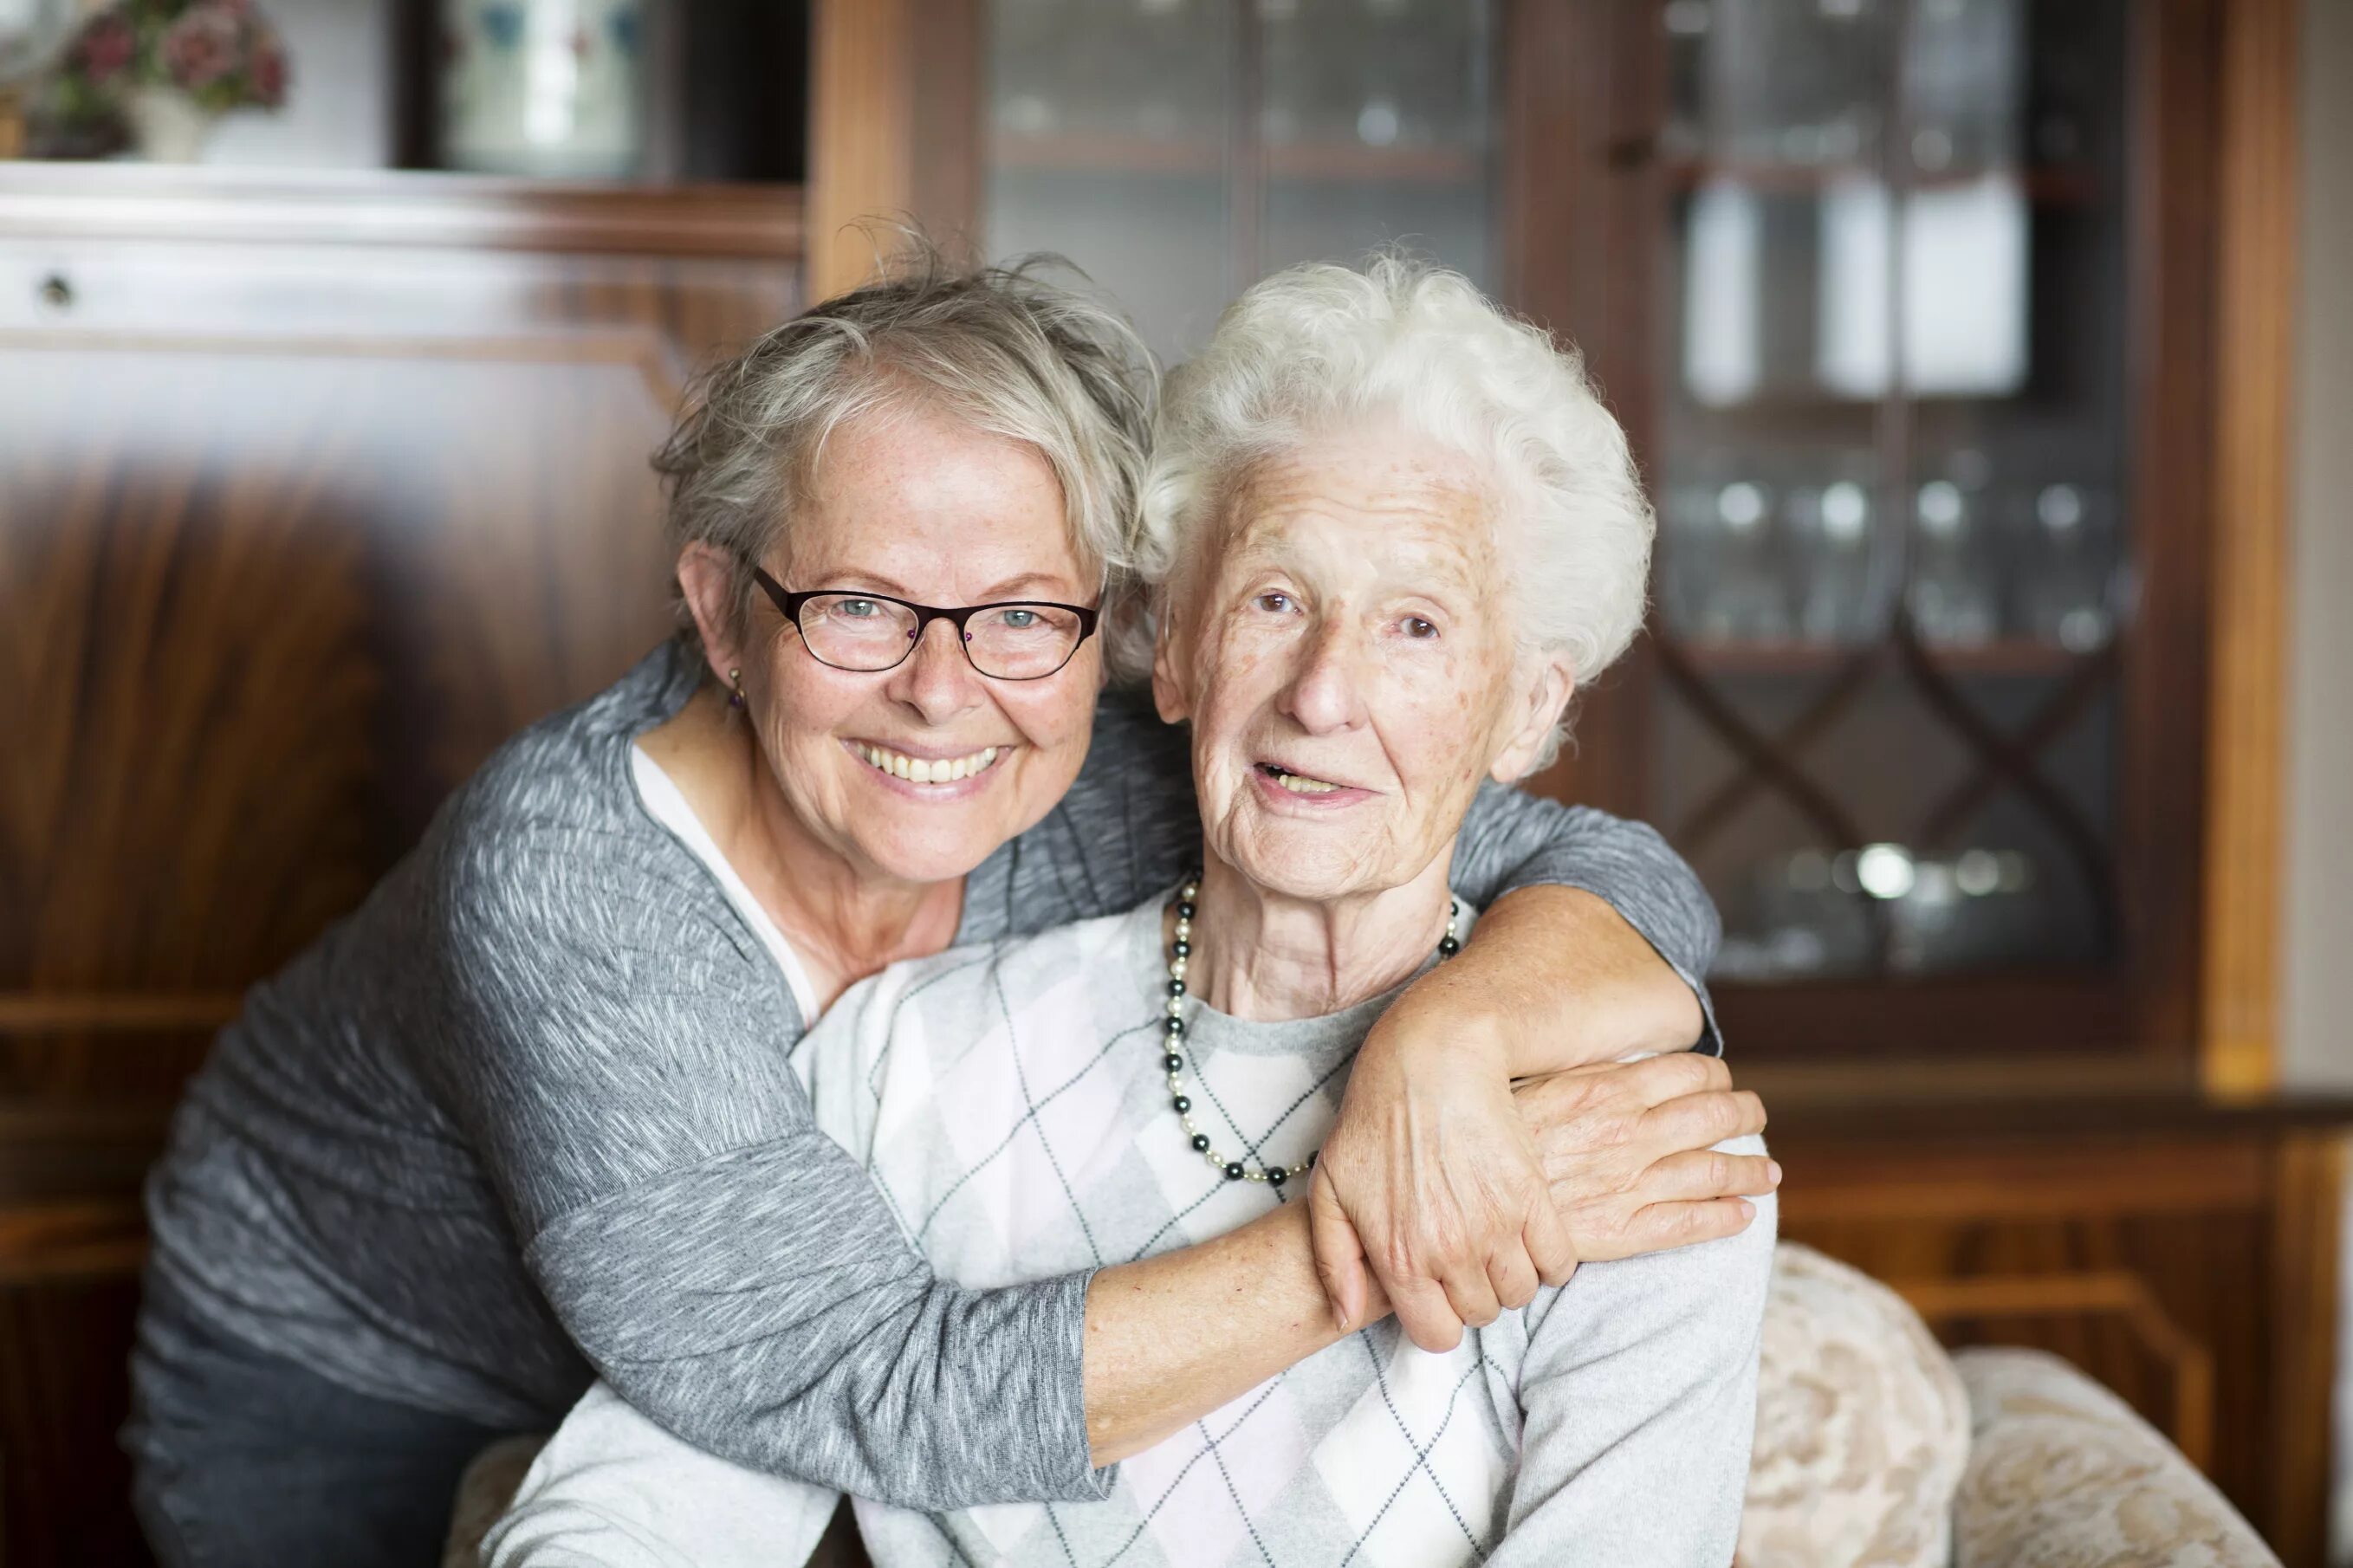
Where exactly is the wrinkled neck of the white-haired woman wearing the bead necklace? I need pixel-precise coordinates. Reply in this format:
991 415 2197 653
1189 855 1452 1021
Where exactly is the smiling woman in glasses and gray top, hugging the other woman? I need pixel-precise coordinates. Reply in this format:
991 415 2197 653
125 250 1739 1568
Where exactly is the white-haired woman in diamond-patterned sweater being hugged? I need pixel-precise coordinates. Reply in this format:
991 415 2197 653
487 259 1777 1568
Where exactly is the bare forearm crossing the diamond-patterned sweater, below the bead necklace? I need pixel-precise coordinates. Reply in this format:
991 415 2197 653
1087 1201 1388 1464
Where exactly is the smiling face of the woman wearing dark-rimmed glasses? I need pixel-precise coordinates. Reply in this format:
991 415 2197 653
743 407 1101 883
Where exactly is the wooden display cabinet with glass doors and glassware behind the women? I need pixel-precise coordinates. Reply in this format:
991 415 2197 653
812 0 2294 1088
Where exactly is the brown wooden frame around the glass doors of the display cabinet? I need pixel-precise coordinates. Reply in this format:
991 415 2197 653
809 0 2294 1090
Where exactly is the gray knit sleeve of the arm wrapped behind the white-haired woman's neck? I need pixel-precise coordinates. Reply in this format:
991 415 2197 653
957 692 1722 1055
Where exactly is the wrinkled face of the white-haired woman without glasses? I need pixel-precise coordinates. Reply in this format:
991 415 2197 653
1153 429 1570 902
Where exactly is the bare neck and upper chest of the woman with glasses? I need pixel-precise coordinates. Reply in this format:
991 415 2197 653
640 690 965 1003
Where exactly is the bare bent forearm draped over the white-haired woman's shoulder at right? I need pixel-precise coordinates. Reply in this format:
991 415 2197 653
1384 885 1706 1079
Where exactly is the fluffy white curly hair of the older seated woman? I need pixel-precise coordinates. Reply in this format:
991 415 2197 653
1120 252 1654 761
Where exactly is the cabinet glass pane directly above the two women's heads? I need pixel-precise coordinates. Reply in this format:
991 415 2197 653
979 0 1499 360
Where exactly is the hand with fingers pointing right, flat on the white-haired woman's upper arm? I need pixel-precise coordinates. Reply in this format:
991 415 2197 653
1513 1053 1781 1262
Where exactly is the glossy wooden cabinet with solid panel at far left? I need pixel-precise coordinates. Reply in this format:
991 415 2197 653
0 165 800 1564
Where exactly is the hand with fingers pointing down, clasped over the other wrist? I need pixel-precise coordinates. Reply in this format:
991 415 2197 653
1308 1029 1577 1351
